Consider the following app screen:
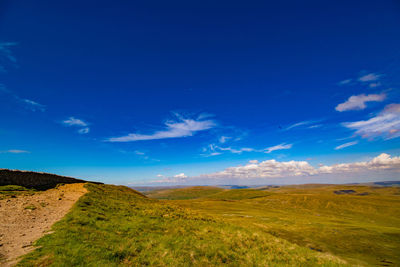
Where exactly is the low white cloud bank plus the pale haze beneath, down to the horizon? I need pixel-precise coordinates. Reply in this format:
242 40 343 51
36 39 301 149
151 153 400 184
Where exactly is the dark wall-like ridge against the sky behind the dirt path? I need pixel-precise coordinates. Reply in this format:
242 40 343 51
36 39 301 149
0 169 101 190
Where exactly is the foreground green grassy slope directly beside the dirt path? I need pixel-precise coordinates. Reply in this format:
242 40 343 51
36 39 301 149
19 184 344 266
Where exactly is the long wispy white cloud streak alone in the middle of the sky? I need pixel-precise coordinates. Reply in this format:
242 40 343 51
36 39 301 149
107 117 216 142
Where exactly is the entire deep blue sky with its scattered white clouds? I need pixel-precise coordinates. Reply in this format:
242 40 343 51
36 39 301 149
0 0 400 185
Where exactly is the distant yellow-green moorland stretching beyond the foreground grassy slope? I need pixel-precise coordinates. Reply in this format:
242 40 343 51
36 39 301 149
169 185 400 266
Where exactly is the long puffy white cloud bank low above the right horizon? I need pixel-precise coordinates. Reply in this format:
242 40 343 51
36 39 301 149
194 153 400 179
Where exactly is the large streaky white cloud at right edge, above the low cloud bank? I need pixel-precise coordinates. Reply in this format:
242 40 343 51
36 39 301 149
343 104 400 139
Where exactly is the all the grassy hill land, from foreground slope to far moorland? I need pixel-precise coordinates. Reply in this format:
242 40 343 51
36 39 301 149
0 173 400 266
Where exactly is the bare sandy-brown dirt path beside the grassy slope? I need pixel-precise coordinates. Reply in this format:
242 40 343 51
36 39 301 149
0 184 87 266
